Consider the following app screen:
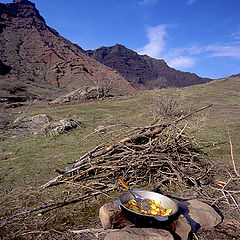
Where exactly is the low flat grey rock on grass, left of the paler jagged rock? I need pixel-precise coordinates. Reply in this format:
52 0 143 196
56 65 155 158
13 114 52 131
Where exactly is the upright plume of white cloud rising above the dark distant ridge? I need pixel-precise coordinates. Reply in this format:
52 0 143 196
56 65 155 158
137 24 167 58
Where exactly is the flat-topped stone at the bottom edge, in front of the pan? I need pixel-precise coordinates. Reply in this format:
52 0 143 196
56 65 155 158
104 228 174 240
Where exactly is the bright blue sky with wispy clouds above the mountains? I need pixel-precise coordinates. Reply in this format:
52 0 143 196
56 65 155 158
0 0 240 78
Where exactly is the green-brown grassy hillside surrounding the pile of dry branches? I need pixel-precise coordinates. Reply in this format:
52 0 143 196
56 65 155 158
0 79 240 239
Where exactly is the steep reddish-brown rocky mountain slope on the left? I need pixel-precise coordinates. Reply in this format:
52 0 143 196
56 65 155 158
0 0 134 99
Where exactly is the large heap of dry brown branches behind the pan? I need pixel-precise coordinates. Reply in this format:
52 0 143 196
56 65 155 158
42 106 213 196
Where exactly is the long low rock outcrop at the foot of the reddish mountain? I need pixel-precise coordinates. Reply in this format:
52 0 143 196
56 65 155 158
50 86 104 104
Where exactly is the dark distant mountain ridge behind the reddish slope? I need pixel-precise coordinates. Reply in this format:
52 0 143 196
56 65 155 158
86 44 211 89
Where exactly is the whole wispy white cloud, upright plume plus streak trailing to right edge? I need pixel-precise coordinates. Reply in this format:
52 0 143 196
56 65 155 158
136 24 240 70
